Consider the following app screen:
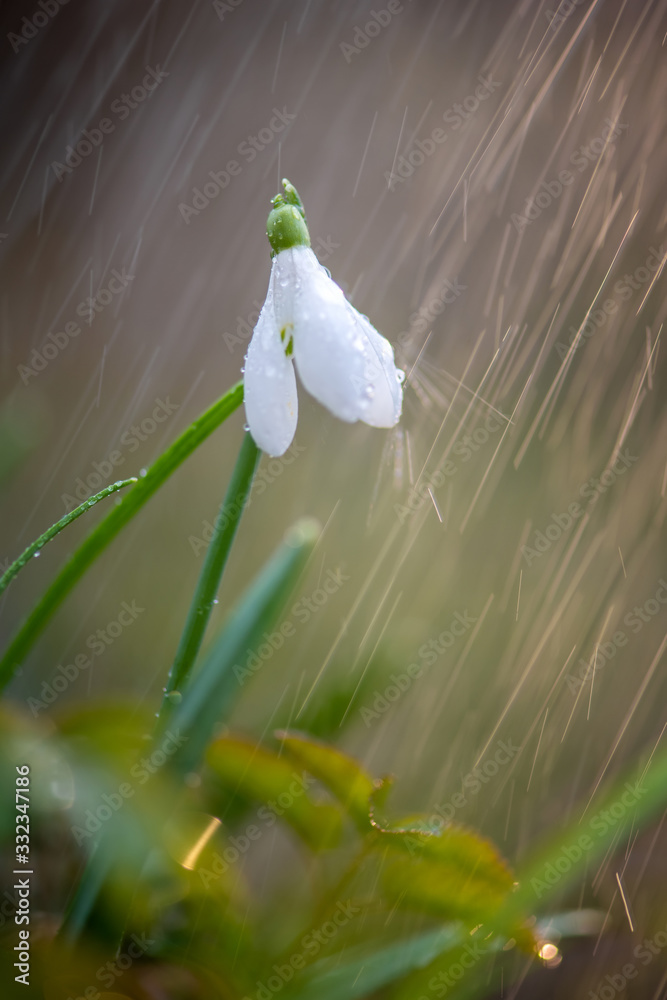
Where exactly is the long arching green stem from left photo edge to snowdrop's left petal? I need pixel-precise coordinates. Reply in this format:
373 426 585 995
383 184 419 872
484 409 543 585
0 382 243 690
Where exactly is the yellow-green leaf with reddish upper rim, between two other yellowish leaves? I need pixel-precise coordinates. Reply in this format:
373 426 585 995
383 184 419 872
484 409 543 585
276 730 381 833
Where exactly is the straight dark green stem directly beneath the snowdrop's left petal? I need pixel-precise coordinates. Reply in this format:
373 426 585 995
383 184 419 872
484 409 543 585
160 433 260 719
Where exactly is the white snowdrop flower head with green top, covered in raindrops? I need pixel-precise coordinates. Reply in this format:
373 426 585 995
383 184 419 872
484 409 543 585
244 180 404 456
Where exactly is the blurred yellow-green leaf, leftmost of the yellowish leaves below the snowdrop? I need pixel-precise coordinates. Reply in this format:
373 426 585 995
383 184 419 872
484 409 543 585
206 736 342 850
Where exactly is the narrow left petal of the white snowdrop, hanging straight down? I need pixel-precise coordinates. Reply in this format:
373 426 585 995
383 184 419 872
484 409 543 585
243 272 298 457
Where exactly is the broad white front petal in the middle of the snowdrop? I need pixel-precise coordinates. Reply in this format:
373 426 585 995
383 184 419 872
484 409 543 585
273 247 371 422
